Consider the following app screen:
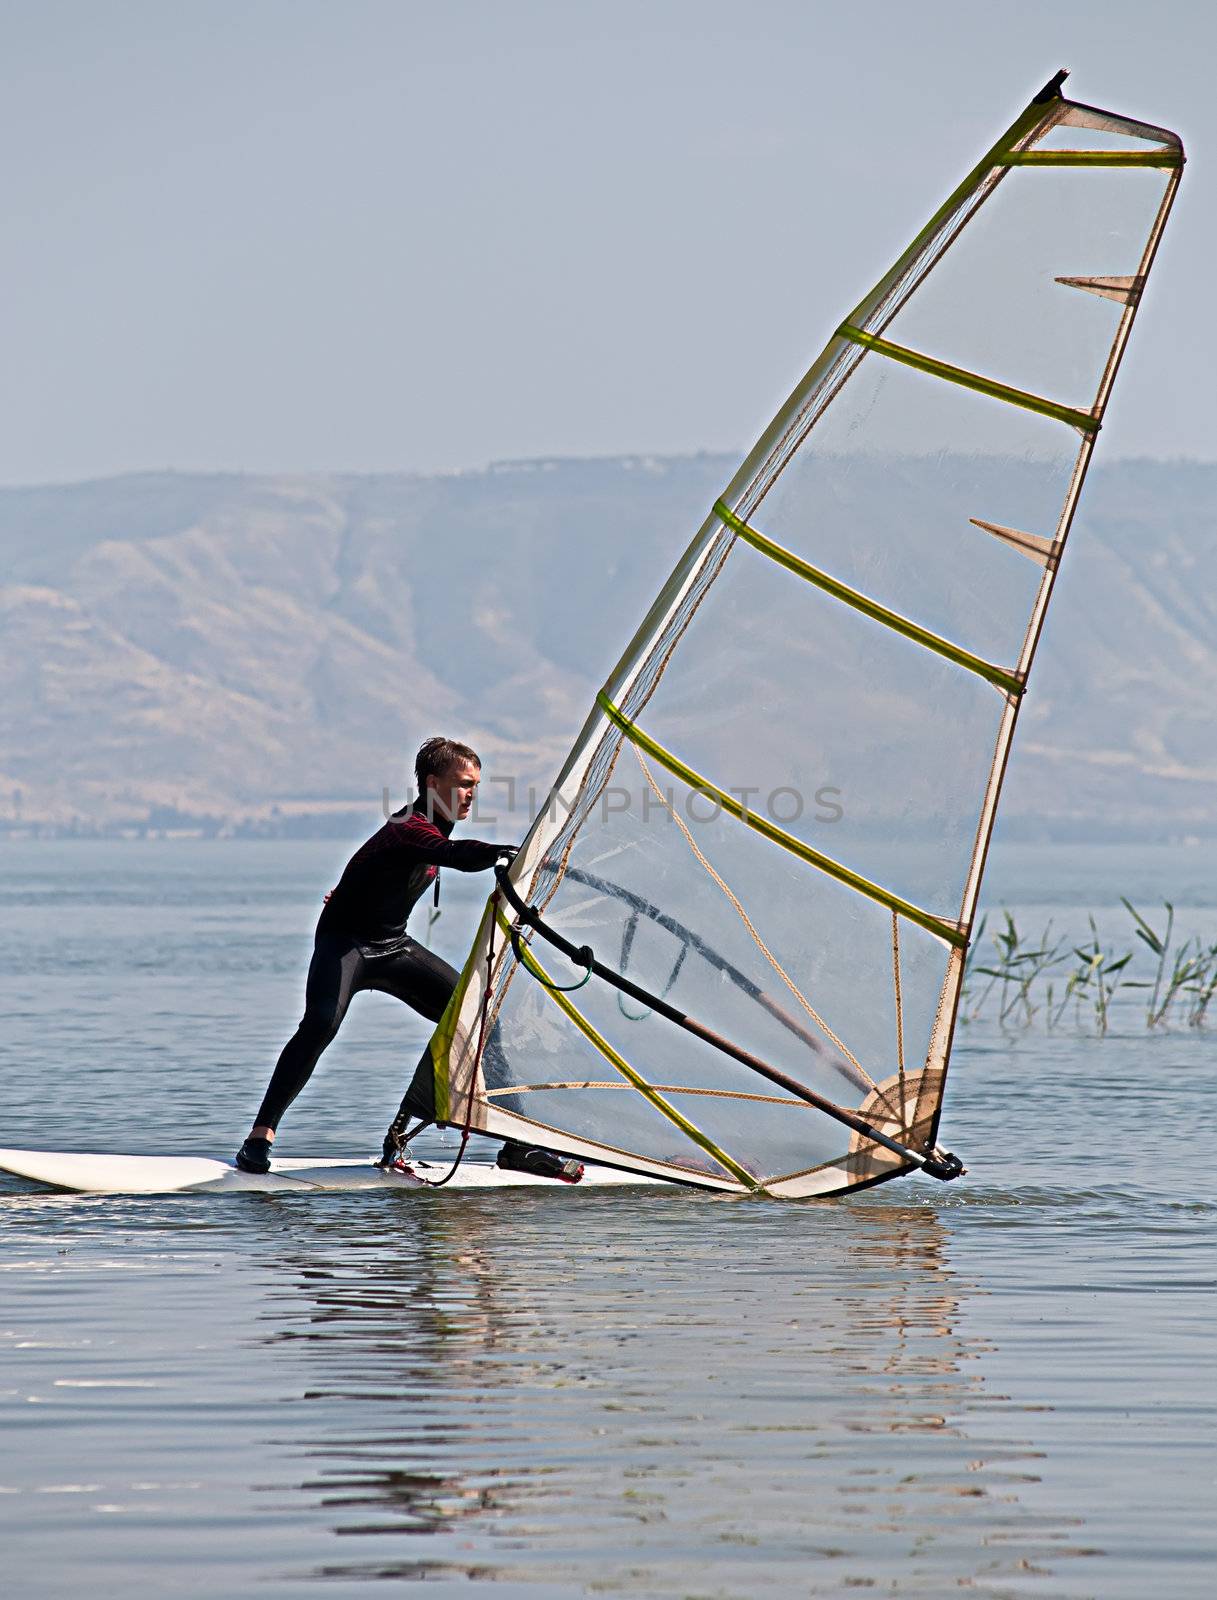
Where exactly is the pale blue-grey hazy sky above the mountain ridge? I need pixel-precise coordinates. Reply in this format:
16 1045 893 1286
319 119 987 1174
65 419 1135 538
0 0 1217 483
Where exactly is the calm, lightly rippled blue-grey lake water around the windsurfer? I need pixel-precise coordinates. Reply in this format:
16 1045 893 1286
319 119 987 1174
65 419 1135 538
0 842 1217 1600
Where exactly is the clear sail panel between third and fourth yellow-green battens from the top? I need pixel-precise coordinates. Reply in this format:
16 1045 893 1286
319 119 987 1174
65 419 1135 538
636 550 1004 918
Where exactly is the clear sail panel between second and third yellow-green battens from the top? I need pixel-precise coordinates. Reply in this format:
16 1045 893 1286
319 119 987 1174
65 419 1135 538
750 360 1074 667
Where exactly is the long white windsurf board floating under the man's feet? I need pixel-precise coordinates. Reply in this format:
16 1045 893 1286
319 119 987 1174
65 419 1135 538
0 1149 668 1195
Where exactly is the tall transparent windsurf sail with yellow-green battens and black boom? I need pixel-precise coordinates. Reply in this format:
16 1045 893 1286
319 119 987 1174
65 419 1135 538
406 74 1183 1197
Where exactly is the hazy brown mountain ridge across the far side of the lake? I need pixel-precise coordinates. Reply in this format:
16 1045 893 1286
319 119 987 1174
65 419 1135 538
0 454 1217 838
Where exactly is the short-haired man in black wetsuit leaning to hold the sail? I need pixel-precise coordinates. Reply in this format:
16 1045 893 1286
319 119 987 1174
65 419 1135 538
237 738 582 1182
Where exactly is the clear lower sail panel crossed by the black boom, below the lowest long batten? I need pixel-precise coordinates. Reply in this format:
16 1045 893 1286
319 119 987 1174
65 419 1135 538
512 771 947 1106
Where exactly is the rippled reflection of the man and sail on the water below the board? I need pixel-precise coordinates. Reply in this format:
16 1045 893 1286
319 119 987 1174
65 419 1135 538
251 1194 1087 1595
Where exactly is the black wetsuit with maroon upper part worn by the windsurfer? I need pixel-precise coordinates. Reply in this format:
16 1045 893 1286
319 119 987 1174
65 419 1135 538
254 800 510 1128
